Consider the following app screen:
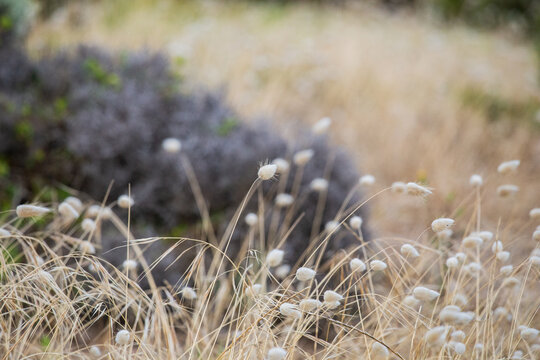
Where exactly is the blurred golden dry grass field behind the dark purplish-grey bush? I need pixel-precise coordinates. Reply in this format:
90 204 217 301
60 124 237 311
6 0 540 236
